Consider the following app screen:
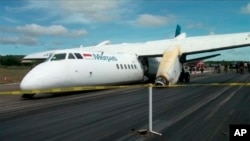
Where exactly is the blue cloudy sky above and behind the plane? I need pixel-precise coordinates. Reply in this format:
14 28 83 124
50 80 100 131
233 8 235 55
0 0 250 60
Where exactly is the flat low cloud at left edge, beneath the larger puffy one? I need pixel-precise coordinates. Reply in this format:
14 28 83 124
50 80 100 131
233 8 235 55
0 36 38 45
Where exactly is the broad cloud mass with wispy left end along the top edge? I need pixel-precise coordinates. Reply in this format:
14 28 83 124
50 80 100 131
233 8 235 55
5 0 131 24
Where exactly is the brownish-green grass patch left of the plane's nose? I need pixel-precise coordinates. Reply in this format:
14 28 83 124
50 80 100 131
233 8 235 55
0 66 31 84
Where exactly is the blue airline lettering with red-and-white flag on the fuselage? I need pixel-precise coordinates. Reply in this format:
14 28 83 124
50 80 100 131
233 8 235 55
83 53 118 62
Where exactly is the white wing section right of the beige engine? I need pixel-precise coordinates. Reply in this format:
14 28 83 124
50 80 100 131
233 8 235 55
180 32 250 55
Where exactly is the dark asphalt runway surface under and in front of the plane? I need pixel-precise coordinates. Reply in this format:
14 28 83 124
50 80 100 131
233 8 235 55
0 73 250 141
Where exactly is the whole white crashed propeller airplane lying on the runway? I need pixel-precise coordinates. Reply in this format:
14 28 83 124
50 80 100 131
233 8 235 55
20 25 250 96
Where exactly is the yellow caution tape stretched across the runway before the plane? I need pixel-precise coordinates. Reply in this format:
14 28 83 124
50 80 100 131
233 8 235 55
0 83 250 95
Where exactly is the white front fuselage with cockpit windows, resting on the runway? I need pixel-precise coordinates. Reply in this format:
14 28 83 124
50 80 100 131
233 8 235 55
20 51 144 90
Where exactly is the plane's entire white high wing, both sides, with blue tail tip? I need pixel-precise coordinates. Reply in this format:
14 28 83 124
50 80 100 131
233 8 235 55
21 25 250 62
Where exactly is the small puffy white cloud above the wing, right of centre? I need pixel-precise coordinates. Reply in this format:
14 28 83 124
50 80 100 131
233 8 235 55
135 14 174 27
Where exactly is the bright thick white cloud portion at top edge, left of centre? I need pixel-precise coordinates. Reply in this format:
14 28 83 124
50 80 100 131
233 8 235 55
58 0 125 23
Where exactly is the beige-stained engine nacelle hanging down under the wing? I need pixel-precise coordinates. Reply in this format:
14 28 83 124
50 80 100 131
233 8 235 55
155 47 182 86
